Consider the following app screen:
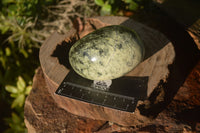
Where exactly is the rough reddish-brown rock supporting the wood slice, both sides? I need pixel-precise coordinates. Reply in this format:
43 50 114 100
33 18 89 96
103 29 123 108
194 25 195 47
24 66 200 133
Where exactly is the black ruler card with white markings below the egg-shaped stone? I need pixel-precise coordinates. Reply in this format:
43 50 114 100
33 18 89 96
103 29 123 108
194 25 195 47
56 71 148 112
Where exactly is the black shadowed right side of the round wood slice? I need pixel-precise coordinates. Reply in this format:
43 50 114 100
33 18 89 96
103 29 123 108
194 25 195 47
138 10 200 117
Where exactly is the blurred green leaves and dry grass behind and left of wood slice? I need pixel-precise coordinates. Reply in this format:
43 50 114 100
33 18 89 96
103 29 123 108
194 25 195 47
0 0 148 133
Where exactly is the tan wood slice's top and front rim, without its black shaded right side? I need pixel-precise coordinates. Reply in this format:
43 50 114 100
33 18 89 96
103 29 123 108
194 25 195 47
40 17 175 126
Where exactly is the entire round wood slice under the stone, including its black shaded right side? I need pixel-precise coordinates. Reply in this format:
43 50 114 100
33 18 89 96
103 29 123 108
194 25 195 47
25 17 200 132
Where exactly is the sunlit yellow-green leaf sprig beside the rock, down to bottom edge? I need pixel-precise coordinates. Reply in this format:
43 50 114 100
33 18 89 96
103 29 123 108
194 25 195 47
5 76 32 133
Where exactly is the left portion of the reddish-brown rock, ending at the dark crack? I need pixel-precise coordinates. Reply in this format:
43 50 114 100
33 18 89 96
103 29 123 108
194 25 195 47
24 68 106 133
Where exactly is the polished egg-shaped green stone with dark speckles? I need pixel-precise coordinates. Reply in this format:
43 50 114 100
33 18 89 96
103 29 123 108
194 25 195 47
69 25 144 80
